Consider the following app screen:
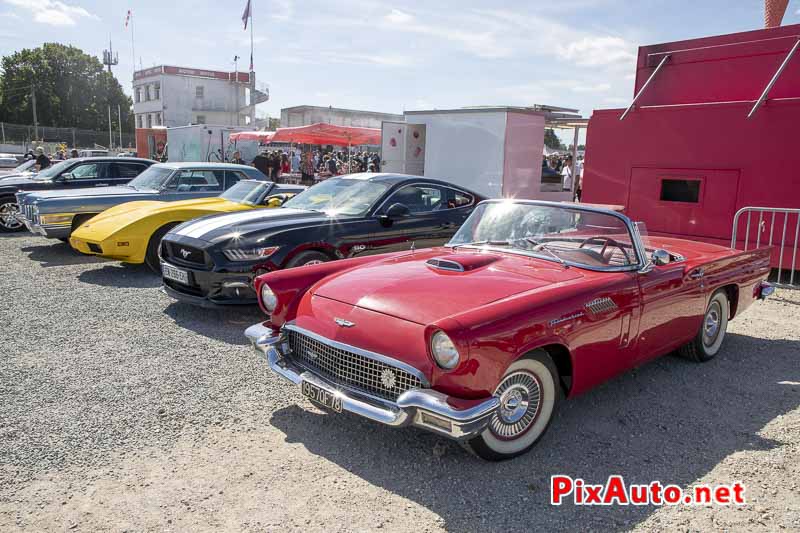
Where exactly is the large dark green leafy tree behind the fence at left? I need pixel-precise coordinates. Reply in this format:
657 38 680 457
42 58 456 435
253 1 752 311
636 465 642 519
0 43 133 133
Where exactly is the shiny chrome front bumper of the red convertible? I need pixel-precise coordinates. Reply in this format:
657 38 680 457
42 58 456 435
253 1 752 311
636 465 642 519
245 324 500 440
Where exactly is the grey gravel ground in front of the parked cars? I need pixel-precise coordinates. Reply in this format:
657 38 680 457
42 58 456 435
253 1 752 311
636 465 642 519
0 234 800 531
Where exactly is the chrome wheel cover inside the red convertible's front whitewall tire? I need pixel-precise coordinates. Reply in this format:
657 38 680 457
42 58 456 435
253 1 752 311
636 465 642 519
489 371 542 440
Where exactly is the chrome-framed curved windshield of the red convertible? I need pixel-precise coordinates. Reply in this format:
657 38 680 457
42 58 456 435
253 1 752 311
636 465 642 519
448 201 639 269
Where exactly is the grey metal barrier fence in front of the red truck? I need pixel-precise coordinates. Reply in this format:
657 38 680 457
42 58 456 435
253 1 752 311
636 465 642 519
731 207 800 289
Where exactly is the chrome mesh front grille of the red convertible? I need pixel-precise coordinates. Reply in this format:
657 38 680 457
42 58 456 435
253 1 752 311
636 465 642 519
286 329 424 401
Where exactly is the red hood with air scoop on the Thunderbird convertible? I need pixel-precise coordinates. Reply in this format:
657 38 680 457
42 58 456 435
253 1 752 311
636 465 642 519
312 248 582 325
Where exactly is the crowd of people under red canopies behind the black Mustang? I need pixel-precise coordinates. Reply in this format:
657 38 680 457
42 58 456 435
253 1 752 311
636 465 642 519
244 150 381 185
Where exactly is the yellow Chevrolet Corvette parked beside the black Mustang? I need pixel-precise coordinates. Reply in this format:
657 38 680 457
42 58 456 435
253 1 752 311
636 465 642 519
69 180 304 272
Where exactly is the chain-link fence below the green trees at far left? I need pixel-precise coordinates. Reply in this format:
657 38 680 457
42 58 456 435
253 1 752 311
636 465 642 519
0 122 136 151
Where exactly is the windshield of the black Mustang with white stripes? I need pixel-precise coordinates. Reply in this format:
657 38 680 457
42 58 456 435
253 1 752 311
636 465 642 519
283 178 389 216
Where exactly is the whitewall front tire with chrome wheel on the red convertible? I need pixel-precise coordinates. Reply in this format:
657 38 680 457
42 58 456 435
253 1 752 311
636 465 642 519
465 350 561 461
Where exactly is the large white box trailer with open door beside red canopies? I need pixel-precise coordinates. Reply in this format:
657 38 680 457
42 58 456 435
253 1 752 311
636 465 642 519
381 107 576 201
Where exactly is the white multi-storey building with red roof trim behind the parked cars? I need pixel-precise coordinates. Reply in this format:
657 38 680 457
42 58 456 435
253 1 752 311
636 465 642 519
133 65 269 128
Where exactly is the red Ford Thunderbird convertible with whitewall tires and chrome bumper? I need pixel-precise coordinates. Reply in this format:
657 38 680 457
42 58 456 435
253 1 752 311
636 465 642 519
246 200 773 460
